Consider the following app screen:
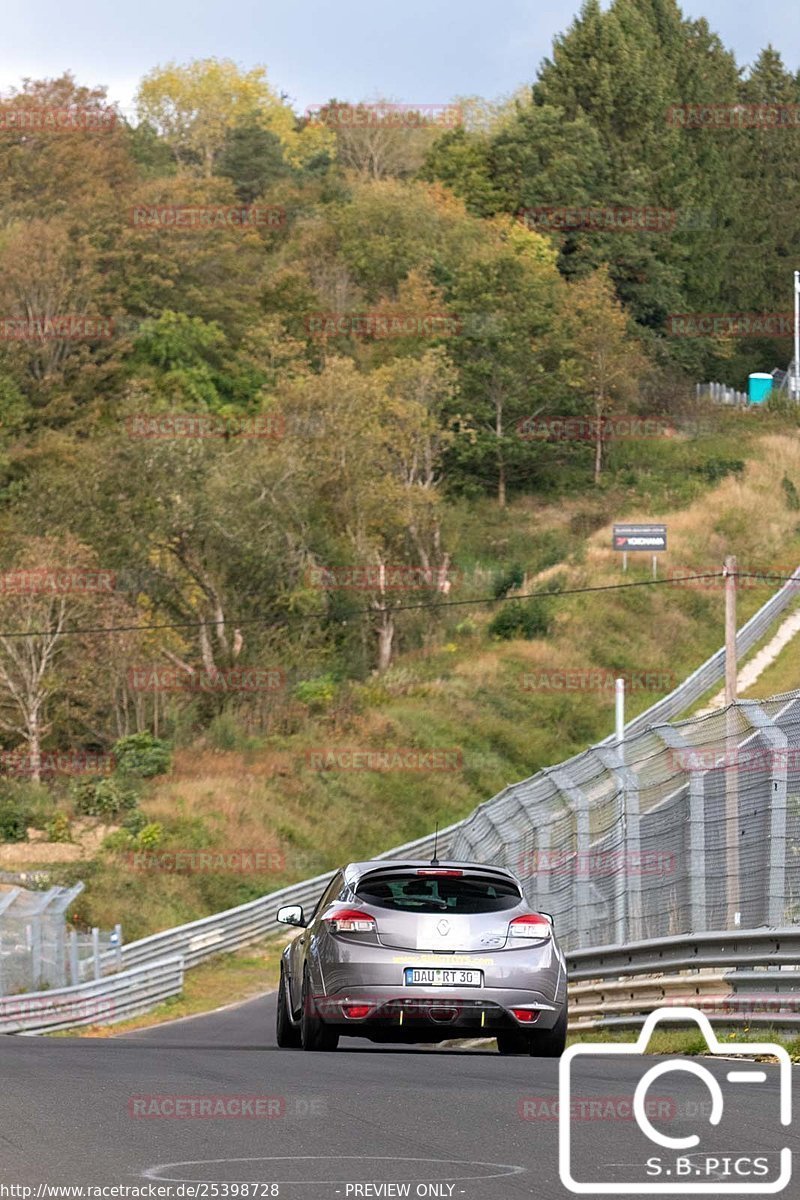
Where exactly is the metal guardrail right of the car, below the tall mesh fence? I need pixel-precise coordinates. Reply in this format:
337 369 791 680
567 926 800 1032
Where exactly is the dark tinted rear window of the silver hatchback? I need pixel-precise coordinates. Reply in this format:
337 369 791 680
356 871 522 913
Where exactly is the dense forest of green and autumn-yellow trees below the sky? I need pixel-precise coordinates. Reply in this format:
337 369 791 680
0 0 800 768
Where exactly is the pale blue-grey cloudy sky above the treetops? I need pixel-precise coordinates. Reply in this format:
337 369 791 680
0 0 800 116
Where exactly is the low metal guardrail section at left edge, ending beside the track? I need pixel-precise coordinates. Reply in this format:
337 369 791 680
0 955 184 1034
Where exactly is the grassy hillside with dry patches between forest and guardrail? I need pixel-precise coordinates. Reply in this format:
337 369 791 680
0 412 800 941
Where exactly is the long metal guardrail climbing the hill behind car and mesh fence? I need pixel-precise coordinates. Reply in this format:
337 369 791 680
6 568 800 1028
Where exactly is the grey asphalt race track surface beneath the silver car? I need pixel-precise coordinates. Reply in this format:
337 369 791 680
0 995 800 1200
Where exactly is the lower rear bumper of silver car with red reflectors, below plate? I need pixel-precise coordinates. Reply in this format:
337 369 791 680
314 986 566 1038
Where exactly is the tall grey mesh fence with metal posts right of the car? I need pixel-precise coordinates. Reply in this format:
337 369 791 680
450 692 800 950
